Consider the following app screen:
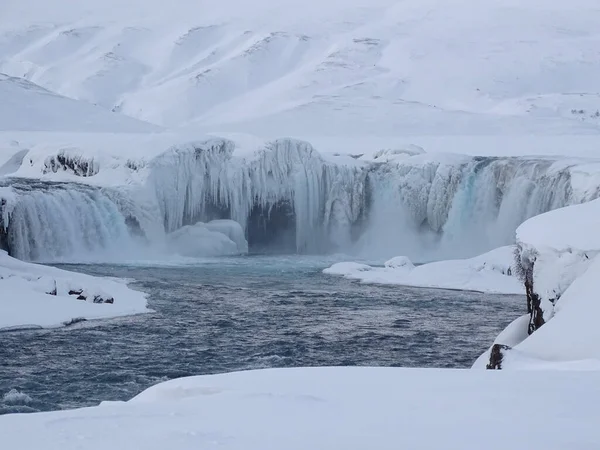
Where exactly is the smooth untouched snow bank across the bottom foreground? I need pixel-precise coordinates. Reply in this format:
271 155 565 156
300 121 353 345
0 367 600 450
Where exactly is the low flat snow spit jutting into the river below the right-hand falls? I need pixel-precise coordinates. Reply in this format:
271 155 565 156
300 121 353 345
323 246 523 294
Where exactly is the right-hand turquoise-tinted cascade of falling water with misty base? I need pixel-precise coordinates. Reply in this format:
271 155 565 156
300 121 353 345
358 158 587 259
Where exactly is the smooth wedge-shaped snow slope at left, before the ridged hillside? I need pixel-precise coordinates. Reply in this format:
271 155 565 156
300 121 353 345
0 73 160 132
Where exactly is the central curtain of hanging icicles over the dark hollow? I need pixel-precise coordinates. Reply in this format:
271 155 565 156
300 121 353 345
149 139 364 252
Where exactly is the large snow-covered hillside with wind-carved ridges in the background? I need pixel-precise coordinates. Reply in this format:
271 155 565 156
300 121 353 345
0 0 600 137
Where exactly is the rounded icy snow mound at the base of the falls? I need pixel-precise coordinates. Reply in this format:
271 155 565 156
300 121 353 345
167 220 248 257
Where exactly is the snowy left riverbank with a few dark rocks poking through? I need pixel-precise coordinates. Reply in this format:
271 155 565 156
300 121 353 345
0 250 149 330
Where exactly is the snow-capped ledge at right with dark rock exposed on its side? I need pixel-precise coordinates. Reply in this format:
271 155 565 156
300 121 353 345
474 200 600 369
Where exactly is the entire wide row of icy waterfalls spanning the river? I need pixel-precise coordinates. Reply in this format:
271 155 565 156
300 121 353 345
0 137 599 262
